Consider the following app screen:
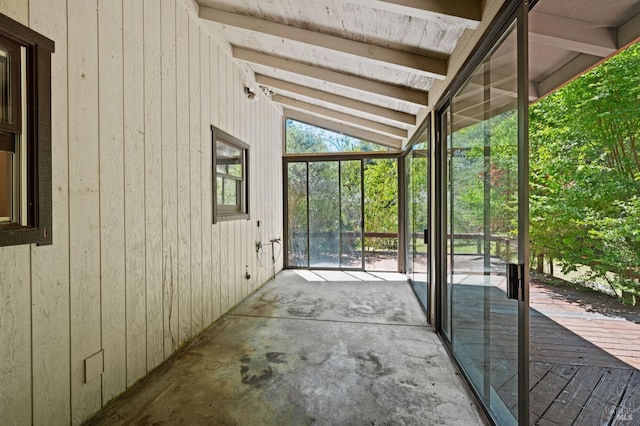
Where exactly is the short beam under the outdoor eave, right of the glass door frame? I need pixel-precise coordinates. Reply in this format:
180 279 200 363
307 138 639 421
529 11 618 58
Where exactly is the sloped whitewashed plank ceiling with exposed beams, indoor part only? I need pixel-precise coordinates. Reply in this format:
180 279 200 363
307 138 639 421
198 0 482 149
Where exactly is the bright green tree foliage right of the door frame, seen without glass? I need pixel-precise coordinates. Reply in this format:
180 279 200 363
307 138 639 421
530 40 640 296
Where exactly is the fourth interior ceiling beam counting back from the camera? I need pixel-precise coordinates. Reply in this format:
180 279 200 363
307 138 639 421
256 74 417 126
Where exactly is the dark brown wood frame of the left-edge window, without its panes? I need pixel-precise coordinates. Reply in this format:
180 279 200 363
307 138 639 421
0 14 55 246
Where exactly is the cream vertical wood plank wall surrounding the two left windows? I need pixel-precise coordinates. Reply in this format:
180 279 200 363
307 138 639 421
0 0 283 424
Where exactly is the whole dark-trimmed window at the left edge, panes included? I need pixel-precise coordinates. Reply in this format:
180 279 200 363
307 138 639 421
0 14 54 246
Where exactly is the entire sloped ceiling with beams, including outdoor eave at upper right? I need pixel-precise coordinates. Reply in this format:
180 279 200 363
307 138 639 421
198 0 640 149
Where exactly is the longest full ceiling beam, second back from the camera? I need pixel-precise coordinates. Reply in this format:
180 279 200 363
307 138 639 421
200 7 447 79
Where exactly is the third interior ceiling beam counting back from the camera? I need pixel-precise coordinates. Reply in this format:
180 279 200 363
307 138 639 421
233 46 429 107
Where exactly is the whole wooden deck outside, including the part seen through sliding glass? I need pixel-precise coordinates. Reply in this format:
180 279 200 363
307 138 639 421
452 274 640 426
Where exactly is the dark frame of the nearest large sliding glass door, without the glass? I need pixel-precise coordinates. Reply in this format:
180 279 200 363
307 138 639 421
432 0 534 424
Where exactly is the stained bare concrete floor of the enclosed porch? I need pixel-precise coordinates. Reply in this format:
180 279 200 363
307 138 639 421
88 271 485 425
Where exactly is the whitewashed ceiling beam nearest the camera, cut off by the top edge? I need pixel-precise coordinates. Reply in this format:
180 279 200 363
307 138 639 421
348 0 482 29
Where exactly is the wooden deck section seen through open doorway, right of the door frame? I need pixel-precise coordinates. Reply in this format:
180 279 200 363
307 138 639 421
530 280 640 426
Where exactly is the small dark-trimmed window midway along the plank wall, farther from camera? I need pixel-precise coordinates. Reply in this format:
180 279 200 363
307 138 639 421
211 126 249 222
